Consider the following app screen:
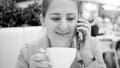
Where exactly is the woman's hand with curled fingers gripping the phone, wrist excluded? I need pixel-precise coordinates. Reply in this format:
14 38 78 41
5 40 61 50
77 20 91 46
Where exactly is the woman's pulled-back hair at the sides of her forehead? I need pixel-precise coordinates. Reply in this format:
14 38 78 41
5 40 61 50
42 0 78 17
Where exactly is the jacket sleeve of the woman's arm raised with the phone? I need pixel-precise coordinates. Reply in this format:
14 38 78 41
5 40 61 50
92 38 106 68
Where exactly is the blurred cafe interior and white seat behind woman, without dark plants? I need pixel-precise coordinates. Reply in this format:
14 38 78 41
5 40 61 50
0 0 120 68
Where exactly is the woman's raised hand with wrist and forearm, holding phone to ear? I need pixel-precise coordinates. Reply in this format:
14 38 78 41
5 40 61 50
77 20 93 66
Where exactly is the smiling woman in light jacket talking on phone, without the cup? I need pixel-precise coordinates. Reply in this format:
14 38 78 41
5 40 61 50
16 0 105 68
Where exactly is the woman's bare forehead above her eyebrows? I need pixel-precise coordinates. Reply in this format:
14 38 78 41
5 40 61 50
47 0 78 13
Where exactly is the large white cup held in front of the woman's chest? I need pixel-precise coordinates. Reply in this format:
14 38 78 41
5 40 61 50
47 47 76 68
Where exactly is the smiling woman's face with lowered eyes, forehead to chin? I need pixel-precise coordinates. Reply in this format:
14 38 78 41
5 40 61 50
43 0 78 46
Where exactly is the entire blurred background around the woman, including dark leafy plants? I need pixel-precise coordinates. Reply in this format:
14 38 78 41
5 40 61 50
0 0 120 68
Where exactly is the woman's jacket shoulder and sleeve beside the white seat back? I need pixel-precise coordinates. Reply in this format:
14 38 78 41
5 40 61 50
16 36 47 67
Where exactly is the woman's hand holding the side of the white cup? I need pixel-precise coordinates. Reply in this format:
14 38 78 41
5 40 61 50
30 49 51 68
